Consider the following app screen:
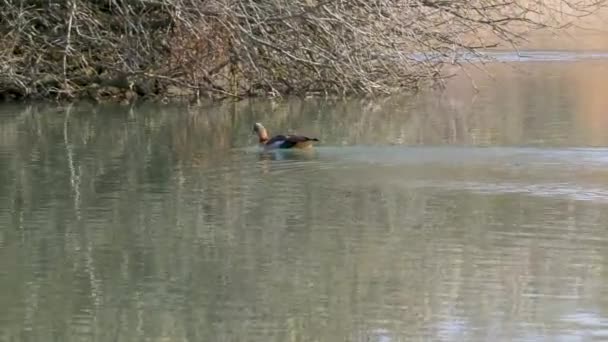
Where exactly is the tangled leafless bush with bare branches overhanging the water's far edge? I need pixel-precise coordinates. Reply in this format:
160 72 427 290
0 0 604 100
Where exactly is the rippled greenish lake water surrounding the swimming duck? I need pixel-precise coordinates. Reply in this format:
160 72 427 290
0 52 608 342
